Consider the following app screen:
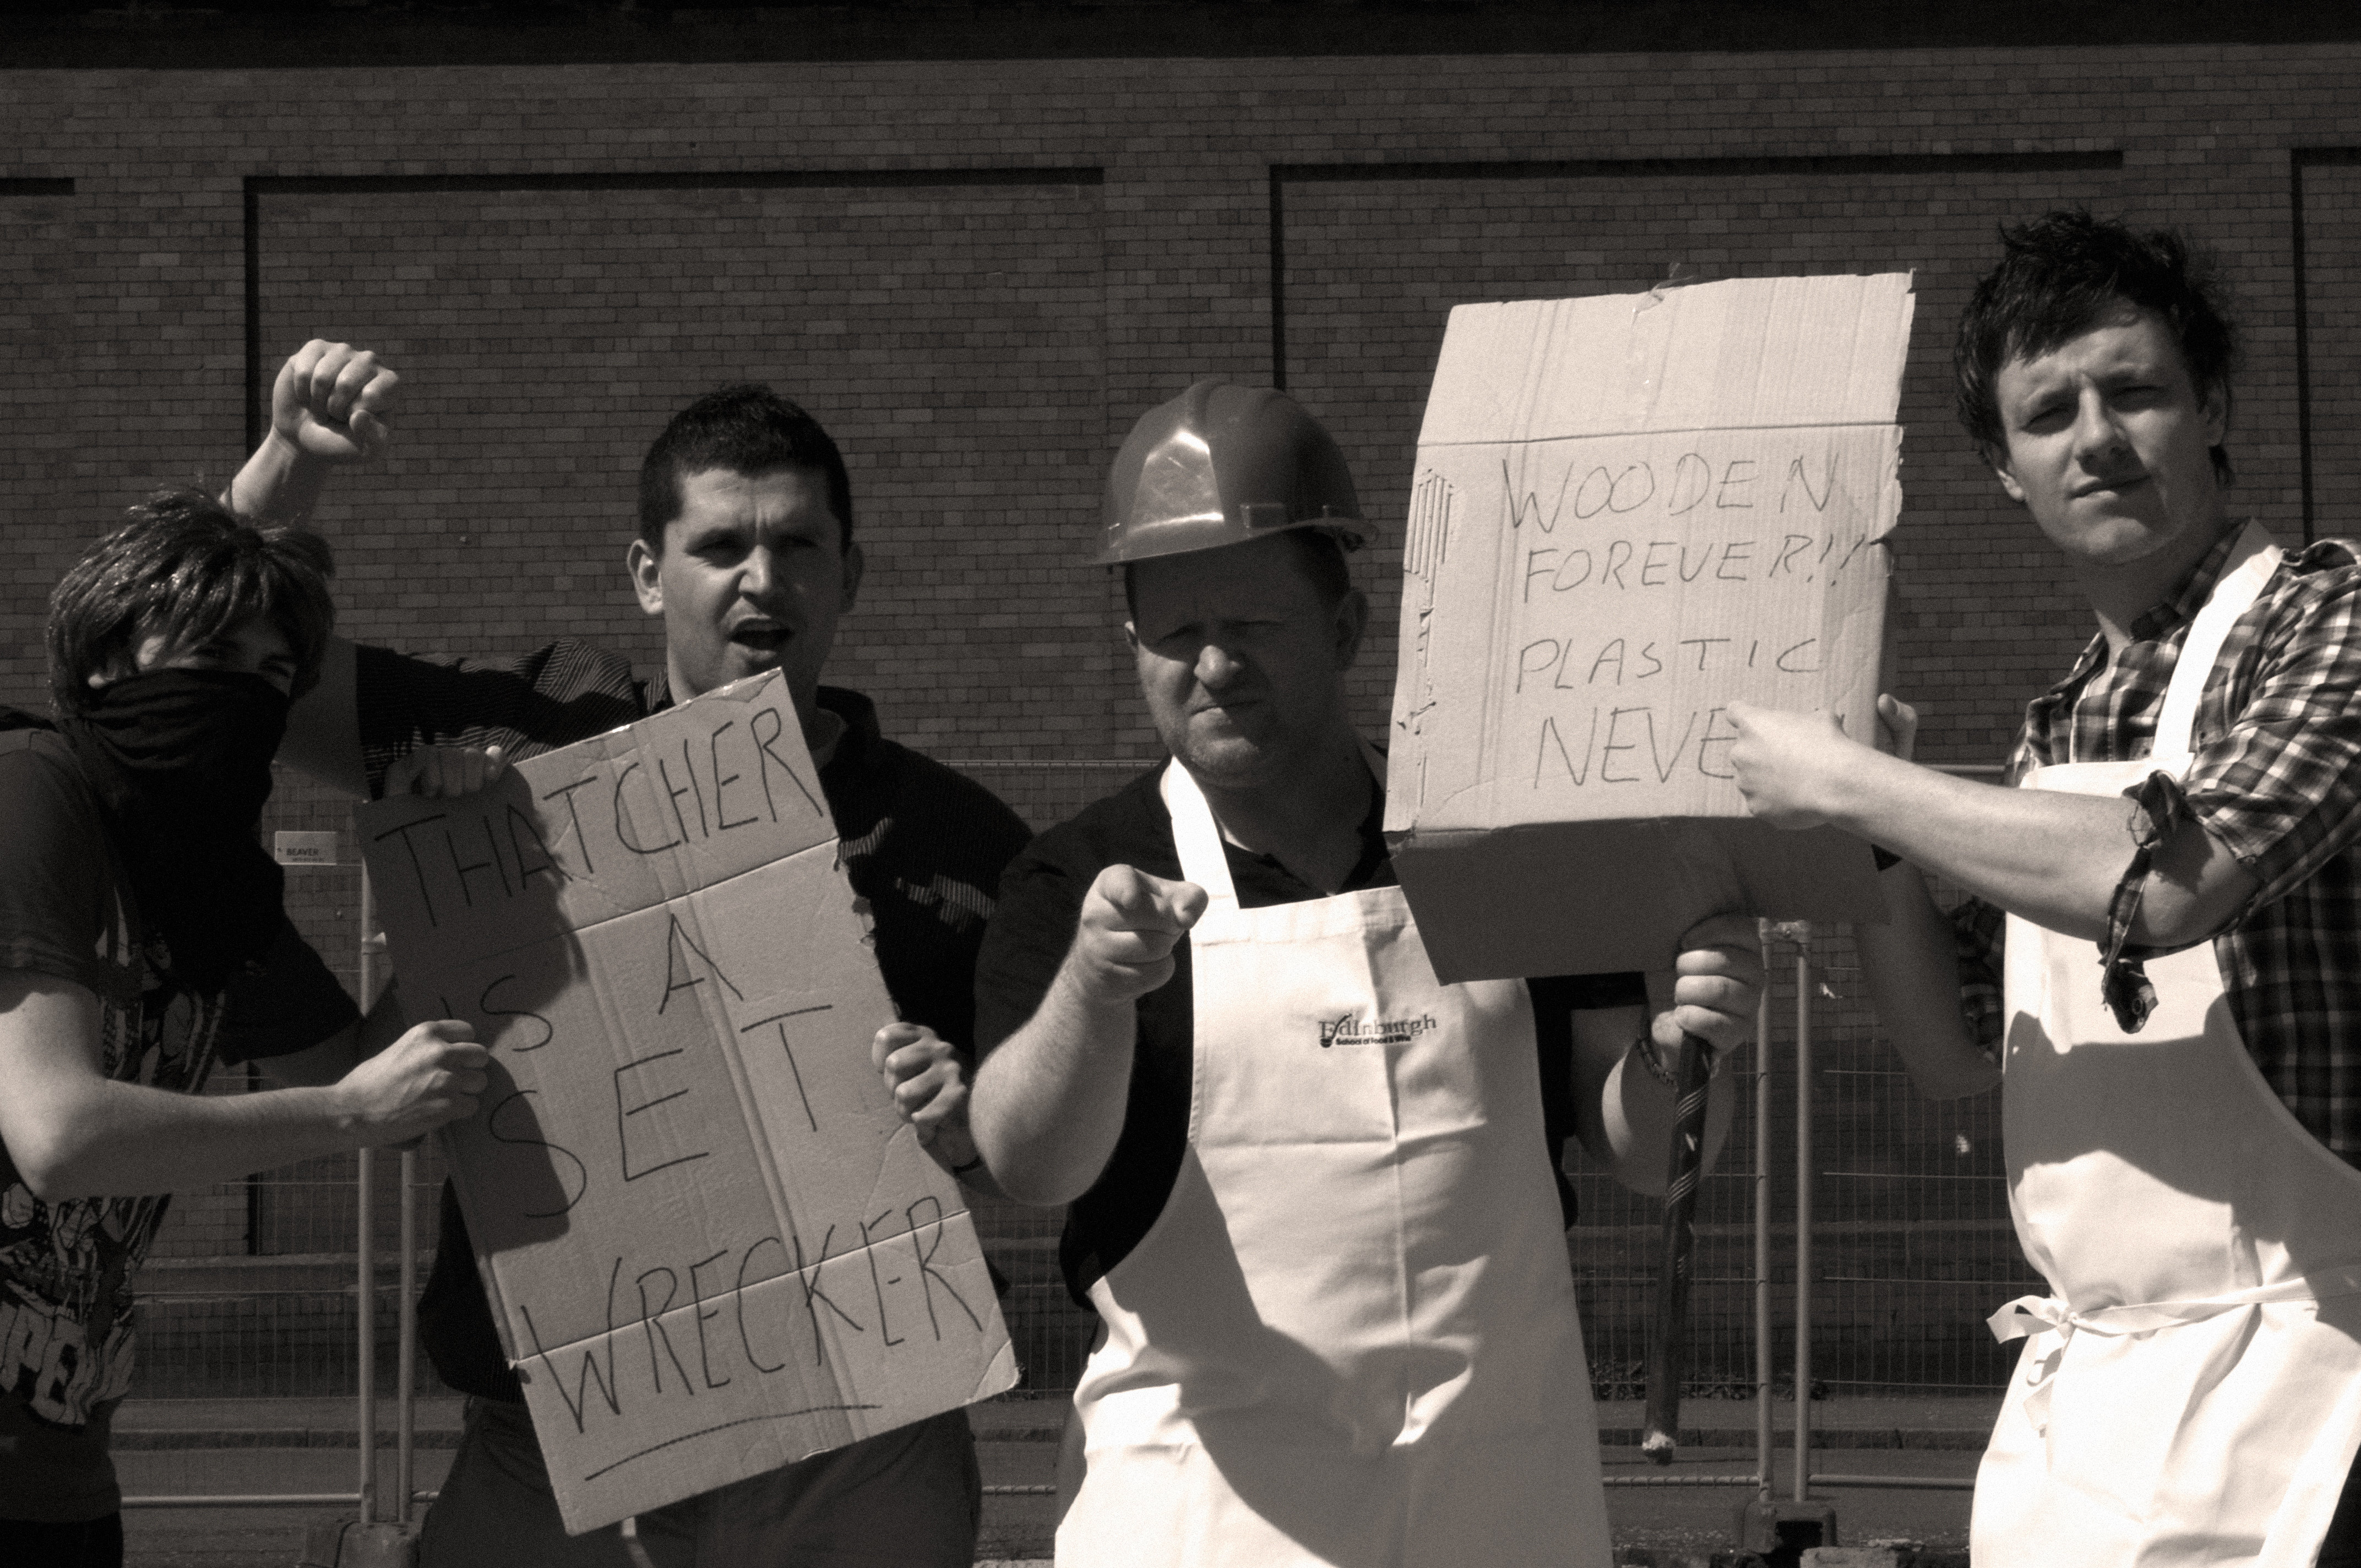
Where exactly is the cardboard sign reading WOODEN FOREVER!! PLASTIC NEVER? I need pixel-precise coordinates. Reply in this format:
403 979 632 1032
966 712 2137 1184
1386 274 1912 980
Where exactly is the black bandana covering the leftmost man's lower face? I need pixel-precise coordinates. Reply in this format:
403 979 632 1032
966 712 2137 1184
59 671 288 989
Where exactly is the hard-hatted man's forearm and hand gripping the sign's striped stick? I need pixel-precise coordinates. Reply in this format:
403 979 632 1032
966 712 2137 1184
1573 914 1764 1195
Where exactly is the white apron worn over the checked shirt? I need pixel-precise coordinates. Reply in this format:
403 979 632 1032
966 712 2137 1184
1969 526 2361 1568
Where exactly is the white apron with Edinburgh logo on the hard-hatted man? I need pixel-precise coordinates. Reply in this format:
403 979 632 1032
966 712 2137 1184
1058 763 1610 1568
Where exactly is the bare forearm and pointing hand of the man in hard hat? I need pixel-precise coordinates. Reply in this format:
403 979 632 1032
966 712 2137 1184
970 867 1206 1207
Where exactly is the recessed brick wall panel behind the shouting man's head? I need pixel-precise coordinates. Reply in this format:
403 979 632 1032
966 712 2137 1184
262 184 1117 756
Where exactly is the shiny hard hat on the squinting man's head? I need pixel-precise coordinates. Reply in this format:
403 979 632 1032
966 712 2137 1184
1098 380 1377 567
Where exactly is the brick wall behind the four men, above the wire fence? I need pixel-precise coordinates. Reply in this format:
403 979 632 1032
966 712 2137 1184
0 45 2361 793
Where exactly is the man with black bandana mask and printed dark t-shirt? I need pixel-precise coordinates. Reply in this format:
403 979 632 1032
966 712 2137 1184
0 491 486 1568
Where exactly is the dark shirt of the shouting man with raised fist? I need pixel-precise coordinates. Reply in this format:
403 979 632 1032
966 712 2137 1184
356 640 1027 1400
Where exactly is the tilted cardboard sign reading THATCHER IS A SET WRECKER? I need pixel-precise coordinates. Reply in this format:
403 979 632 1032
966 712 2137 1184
361 676 1015 1533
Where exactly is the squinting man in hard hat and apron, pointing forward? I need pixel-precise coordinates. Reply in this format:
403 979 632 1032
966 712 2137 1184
949 383 1761 1568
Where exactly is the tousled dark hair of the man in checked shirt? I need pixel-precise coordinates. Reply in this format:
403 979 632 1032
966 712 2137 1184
1952 210 2238 484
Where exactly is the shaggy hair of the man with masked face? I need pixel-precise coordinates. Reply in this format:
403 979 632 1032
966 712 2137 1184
47 489 335 713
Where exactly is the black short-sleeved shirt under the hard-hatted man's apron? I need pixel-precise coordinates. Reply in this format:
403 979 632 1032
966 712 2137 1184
975 763 1648 1306
